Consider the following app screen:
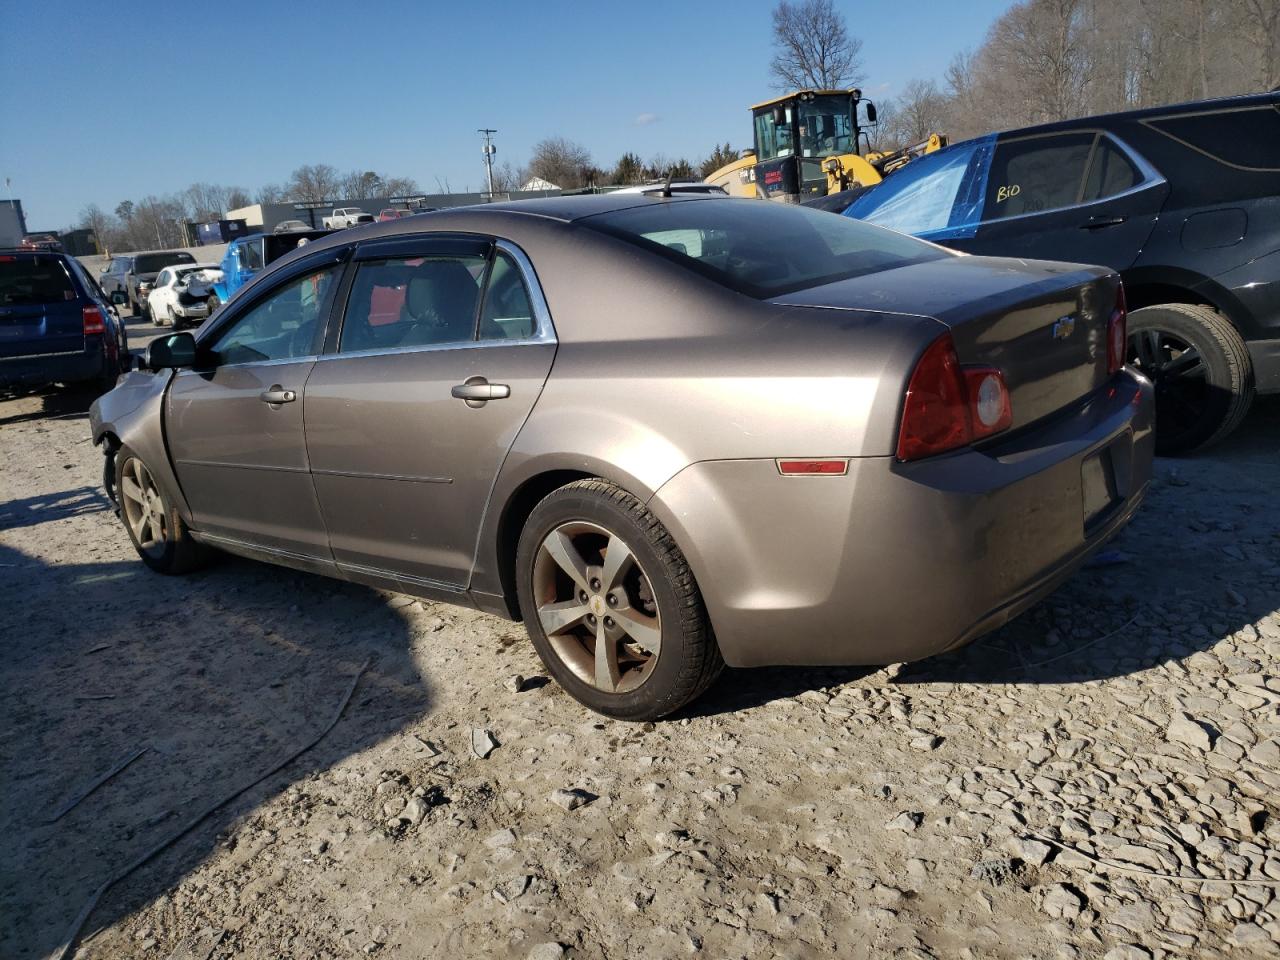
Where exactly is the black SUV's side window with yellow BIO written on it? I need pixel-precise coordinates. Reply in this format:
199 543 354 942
983 133 1097 220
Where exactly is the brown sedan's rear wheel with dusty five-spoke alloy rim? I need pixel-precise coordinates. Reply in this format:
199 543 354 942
516 480 724 721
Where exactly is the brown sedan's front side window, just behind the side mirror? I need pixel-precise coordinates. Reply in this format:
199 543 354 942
210 266 338 365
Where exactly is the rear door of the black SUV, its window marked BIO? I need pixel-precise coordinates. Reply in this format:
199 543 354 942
941 131 1169 270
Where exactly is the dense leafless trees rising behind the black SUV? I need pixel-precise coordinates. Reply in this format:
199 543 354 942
877 0 1280 146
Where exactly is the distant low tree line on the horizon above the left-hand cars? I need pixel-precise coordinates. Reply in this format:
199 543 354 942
78 164 421 251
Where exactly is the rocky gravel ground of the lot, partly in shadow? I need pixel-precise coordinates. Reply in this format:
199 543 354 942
0 371 1280 960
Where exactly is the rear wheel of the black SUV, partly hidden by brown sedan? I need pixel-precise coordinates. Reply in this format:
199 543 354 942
1128 303 1253 457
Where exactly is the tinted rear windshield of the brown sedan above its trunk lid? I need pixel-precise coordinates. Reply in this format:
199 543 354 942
581 200 951 300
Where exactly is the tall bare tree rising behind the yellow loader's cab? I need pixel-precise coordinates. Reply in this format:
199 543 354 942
769 0 863 90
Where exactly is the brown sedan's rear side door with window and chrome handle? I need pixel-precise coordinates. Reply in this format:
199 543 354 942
305 238 556 591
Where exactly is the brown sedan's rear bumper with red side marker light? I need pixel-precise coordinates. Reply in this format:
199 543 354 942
649 372 1155 667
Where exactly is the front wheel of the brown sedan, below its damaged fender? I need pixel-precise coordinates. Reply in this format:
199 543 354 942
115 447 207 573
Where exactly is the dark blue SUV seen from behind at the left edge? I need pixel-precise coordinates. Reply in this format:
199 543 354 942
0 250 128 389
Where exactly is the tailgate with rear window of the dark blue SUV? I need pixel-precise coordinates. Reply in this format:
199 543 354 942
0 253 84 357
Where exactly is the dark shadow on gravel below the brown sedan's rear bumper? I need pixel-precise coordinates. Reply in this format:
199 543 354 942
678 397 1280 717
